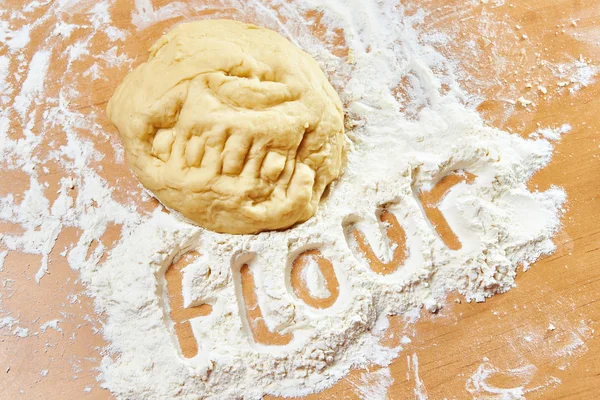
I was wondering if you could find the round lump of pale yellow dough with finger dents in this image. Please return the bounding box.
[107,20,344,234]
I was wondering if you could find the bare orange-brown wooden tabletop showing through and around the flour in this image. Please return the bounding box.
[0,0,600,399]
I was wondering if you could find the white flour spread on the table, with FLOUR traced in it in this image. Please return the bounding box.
[0,0,565,399]
